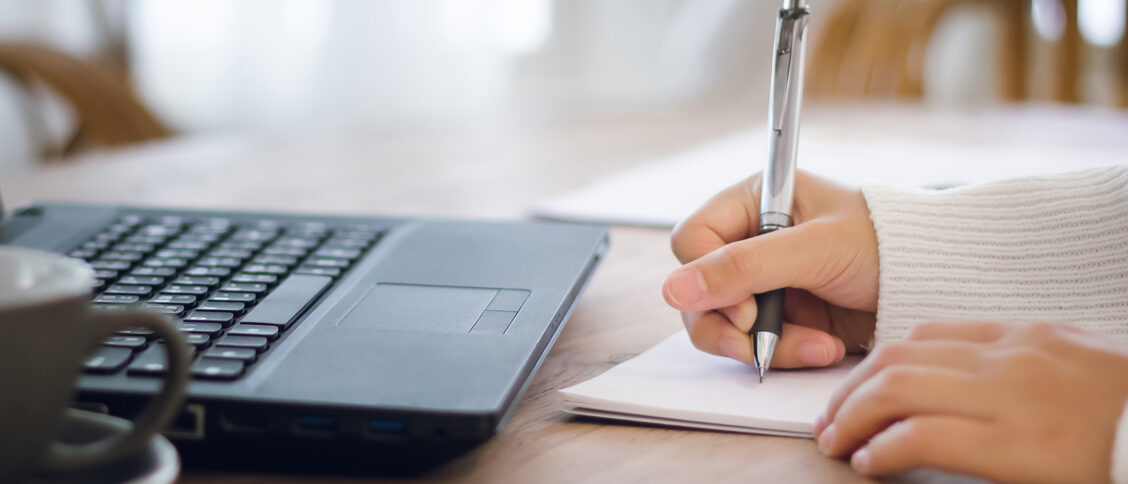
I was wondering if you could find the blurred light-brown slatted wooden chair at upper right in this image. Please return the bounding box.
[808,0,1128,106]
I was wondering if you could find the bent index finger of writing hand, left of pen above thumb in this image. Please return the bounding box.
[670,174,760,264]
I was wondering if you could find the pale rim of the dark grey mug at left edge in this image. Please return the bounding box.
[0,246,94,310]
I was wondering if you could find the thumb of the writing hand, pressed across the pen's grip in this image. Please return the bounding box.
[662,222,836,311]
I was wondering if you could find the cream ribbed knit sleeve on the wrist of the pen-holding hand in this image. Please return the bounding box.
[863,166,1128,343]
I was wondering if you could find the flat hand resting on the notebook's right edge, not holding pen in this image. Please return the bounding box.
[814,323,1128,483]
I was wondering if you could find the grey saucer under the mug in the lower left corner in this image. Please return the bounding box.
[28,408,180,484]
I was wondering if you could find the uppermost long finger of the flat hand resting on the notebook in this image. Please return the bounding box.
[814,341,984,437]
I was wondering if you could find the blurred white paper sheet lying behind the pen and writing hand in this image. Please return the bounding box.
[534,125,1125,227]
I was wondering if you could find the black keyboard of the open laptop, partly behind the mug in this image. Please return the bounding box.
[68,215,384,380]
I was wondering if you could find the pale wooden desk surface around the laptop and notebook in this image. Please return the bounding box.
[0,103,1055,483]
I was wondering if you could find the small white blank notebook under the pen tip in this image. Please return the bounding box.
[561,331,860,438]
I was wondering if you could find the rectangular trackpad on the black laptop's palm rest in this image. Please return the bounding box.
[337,284,507,333]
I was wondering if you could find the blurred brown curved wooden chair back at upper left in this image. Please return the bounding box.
[0,43,170,159]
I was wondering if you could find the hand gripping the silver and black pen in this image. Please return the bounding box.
[662,171,878,368]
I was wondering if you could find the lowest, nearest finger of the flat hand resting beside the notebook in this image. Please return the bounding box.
[851,415,1003,476]
